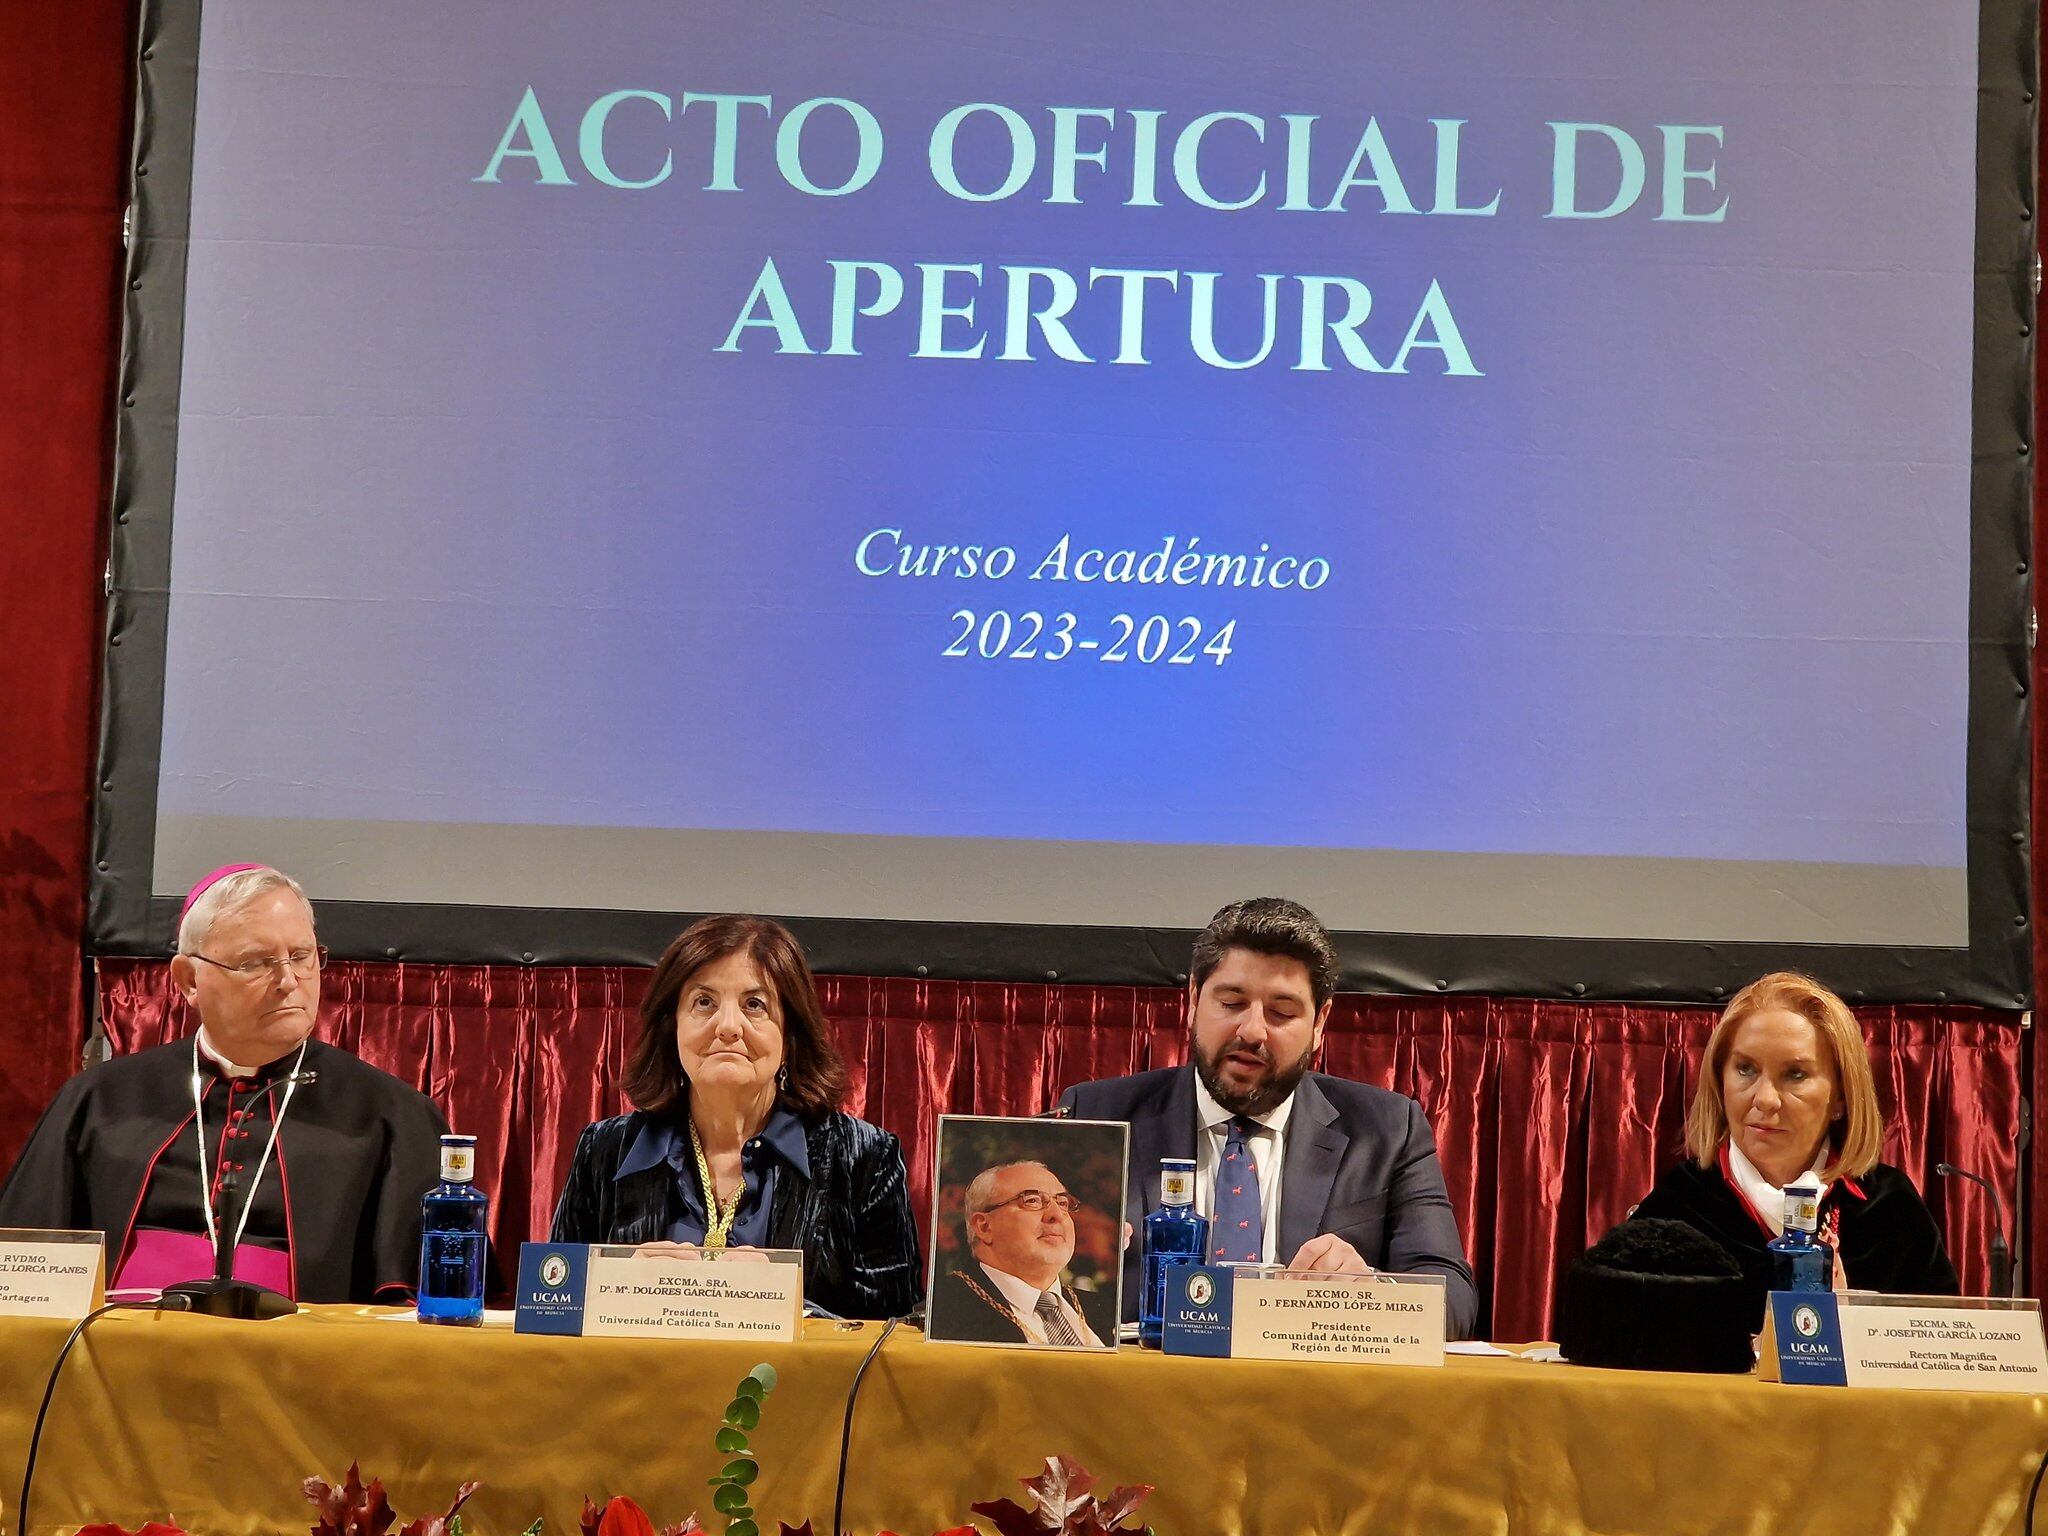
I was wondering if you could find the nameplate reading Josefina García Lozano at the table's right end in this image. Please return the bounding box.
[1757,1290,2048,1393]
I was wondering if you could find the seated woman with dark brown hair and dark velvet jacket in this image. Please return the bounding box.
[551,915,920,1317]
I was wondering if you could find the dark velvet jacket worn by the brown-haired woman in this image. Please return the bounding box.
[551,1110,922,1317]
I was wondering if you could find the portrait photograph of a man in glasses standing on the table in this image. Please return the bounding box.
[924,1114,1130,1350]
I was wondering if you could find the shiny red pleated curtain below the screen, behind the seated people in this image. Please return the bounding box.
[100,961,2023,1339]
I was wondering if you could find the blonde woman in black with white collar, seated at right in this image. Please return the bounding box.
[1632,971,1956,1327]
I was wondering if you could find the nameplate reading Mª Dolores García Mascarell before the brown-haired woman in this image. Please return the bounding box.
[512,1243,803,1339]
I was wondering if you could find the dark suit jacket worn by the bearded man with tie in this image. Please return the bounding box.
[1059,1065,1479,1339]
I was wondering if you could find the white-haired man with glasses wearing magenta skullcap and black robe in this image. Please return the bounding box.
[0,864,446,1303]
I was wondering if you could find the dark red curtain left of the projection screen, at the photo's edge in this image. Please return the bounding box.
[0,0,133,1167]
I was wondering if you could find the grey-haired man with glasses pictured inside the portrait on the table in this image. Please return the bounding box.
[926,1163,1116,1350]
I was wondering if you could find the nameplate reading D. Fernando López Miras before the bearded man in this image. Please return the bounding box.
[1161,1264,1444,1366]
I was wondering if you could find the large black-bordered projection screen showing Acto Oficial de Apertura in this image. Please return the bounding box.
[92,0,2034,1006]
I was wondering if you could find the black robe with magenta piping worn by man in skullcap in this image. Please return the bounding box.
[0,1040,446,1303]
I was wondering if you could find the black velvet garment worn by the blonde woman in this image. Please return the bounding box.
[1630,1159,1956,1331]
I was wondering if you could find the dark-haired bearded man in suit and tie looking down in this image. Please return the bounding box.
[1059,897,1479,1339]
